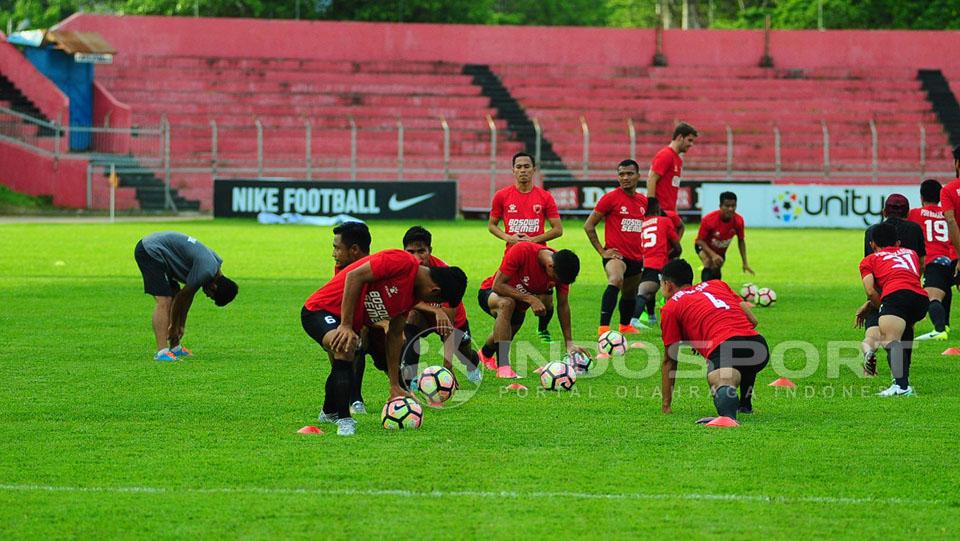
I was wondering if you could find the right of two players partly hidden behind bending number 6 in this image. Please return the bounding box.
[403,225,482,388]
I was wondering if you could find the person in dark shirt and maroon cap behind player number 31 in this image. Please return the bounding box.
[861,193,926,376]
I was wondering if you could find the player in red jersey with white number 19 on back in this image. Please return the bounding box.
[907,178,957,340]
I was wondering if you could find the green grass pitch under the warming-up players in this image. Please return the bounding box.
[0,220,960,539]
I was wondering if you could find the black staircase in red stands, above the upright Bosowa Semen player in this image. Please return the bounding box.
[463,64,573,180]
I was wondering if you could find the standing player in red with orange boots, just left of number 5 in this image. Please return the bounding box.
[583,160,647,336]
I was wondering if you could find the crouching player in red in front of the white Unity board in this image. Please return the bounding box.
[695,192,755,282]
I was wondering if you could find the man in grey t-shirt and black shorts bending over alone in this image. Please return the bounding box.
[133,231,238,361]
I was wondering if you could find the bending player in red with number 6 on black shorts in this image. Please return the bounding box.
[300,250,467,436]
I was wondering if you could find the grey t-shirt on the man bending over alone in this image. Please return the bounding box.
[141,231,223,289]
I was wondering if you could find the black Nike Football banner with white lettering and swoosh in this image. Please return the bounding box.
[213,179,457,220]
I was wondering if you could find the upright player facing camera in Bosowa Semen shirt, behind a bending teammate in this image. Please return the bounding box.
[487,152,563,342]
